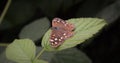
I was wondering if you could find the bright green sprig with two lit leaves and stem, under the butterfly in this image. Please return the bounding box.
[6,18,106,63]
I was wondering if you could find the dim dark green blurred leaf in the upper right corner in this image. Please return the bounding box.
[96,0,120,23]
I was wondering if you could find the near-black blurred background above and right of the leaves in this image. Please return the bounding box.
[0,0,120,63]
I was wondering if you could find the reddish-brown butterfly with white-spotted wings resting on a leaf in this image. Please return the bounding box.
[50,18,75,48]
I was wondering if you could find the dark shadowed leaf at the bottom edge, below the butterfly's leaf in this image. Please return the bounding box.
[50,48,92,63]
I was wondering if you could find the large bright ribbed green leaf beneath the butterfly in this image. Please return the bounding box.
[42,18,106,51]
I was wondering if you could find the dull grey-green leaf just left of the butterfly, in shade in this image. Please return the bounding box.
[19,17,50,41]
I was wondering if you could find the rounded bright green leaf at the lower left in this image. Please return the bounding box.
[6,39,36,63]
